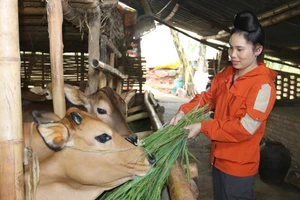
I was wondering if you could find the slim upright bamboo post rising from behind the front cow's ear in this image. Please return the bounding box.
[47,0,66,118]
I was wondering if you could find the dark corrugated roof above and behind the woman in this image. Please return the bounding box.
[142,0,300,65]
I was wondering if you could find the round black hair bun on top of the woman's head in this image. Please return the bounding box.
[233,10,260,32]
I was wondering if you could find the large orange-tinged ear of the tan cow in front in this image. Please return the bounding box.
[37,123,69,151]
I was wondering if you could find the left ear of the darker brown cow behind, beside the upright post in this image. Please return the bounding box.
[64,84,88,106]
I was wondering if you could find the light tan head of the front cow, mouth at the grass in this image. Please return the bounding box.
[37,108,151,190]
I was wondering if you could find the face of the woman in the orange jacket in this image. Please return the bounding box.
[228,33,262,76]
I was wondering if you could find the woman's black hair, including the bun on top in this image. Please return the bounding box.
[231,10,265,46]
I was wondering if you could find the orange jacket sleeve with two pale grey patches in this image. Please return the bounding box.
[200,83,276,142]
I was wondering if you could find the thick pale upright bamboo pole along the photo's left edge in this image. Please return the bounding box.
[0,0,24,200]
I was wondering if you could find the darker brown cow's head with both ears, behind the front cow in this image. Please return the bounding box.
[65,84,136,138]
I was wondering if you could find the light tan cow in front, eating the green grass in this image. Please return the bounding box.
[23,107,155,200]
